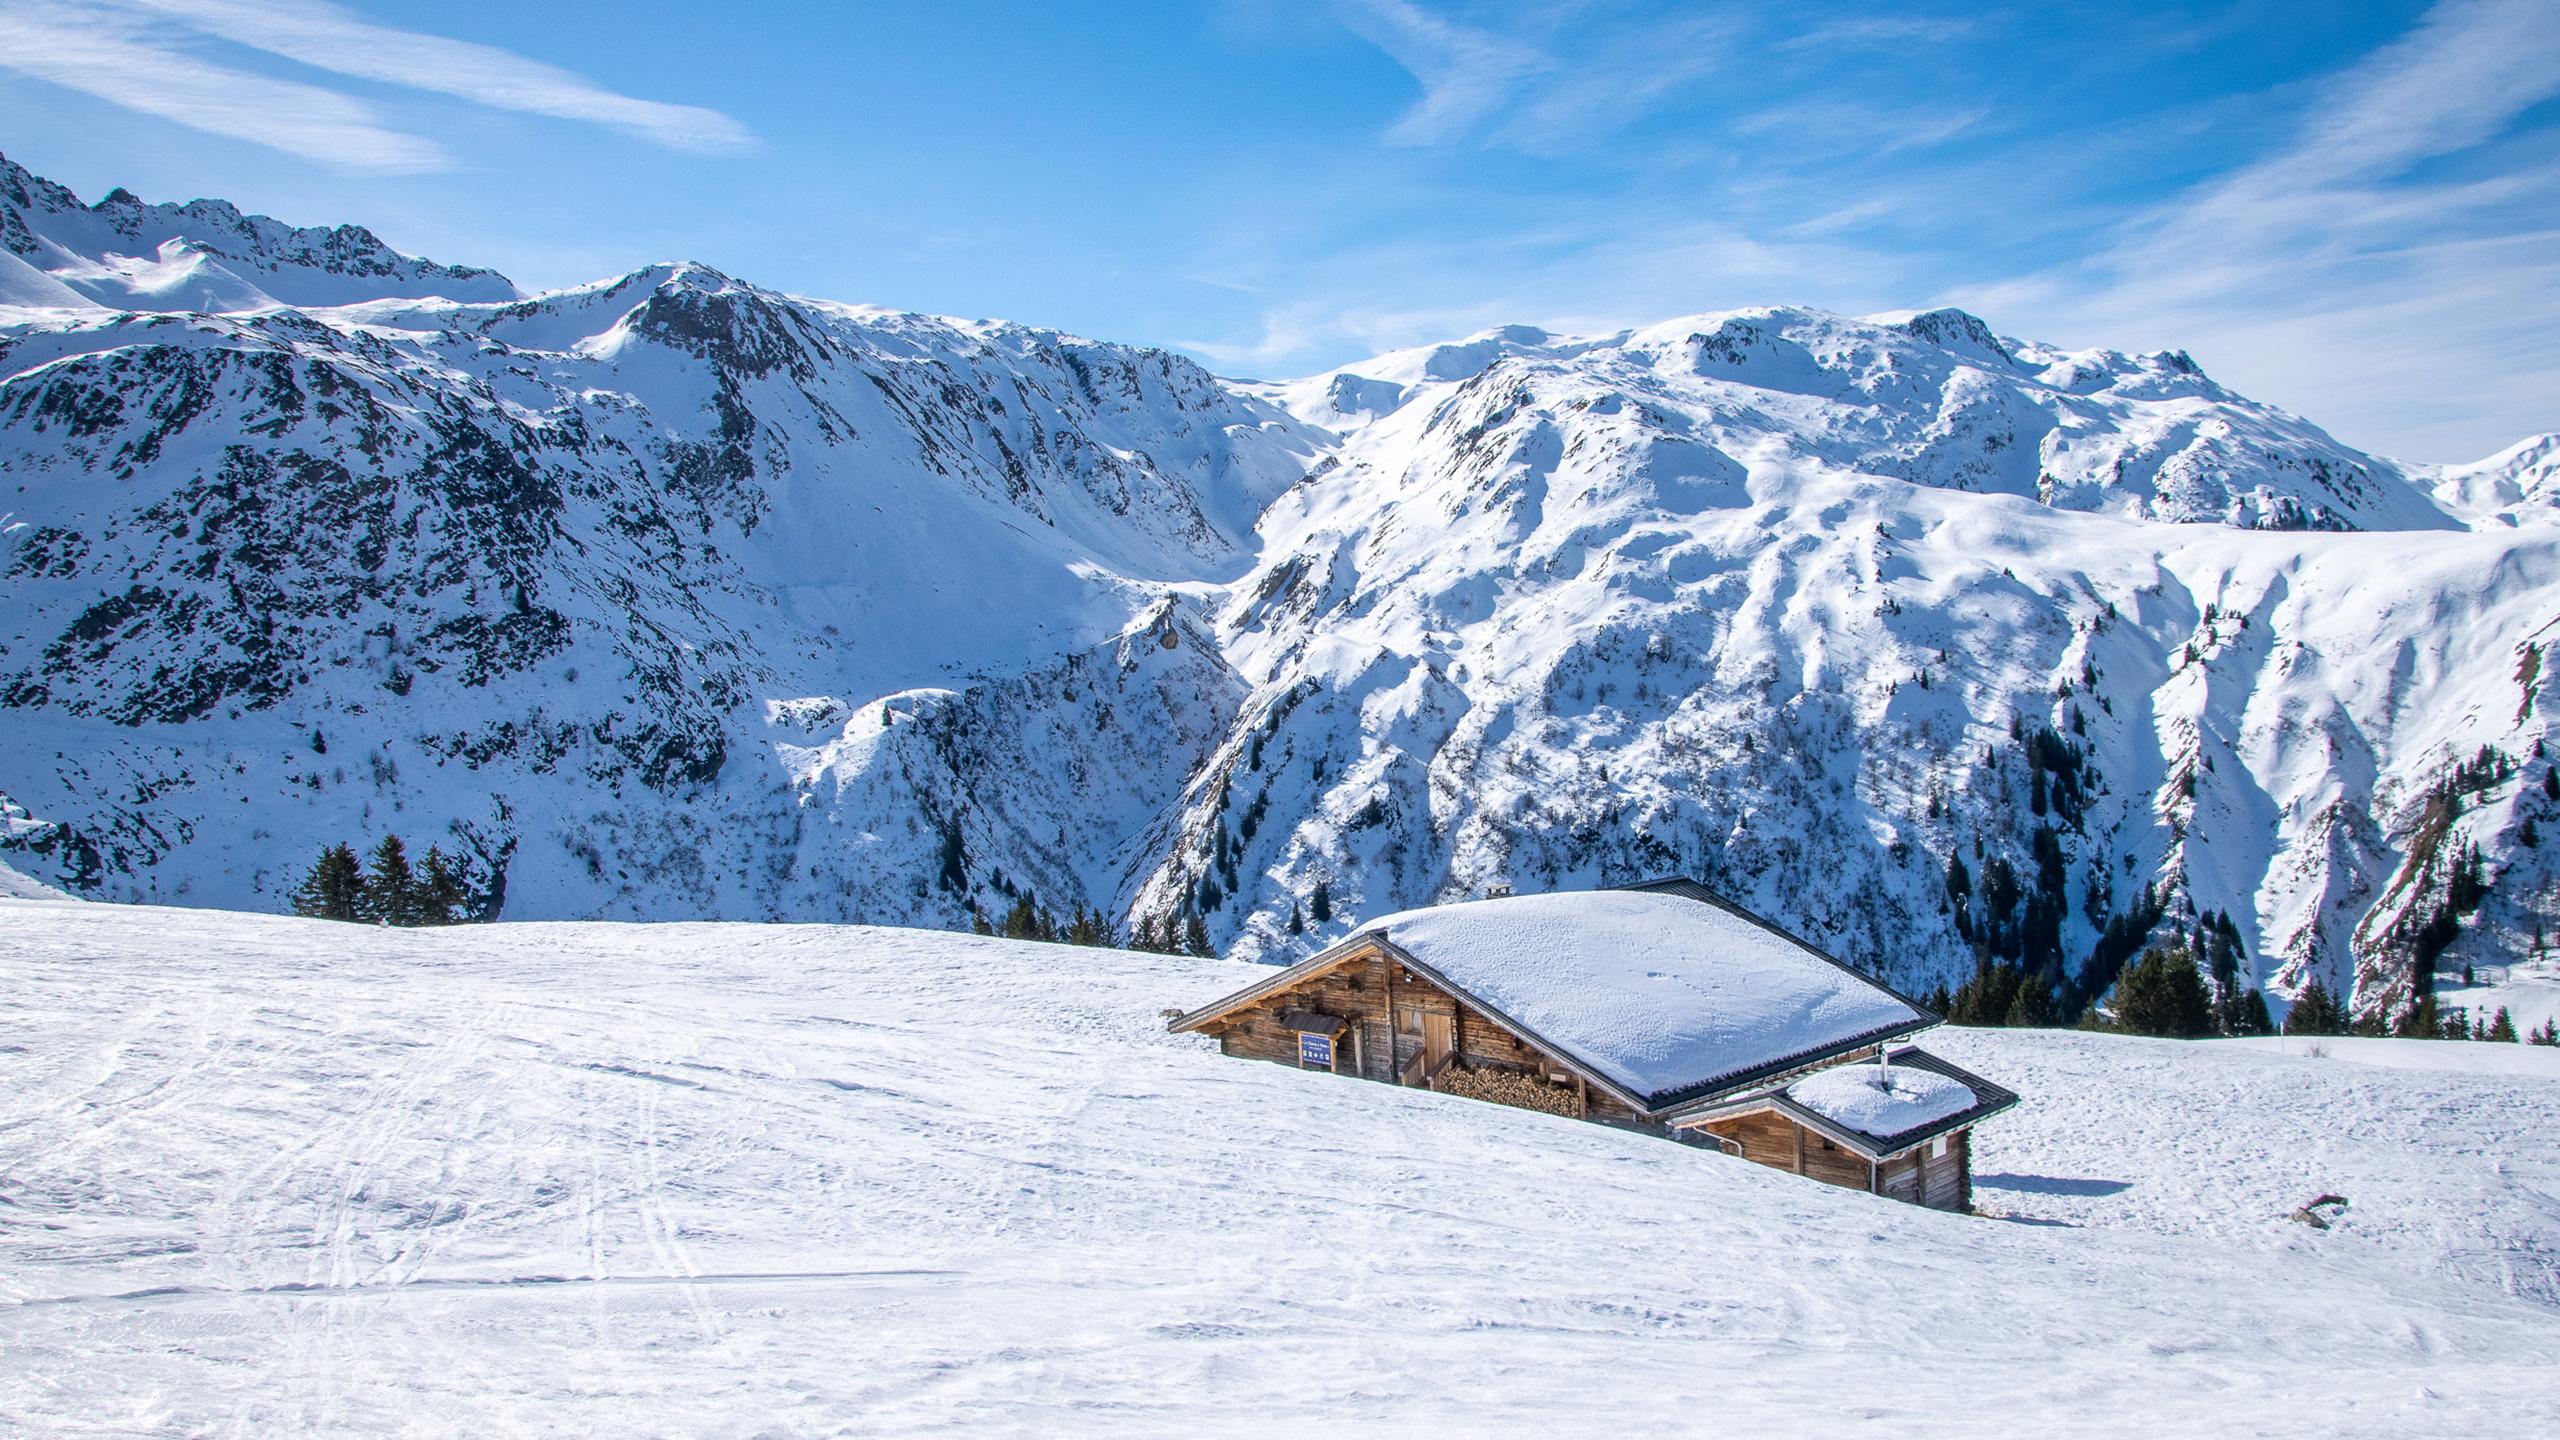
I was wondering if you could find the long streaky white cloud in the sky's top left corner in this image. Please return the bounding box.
[0,0,755,172]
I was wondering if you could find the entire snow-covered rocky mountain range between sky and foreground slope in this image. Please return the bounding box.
[0,161,2560,1010]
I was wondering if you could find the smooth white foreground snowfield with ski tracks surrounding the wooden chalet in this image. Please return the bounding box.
[0,902,2560,1437]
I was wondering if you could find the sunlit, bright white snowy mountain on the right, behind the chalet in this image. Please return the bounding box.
[1187,310,2560,1012]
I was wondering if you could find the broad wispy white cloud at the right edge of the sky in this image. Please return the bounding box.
[1953,0,2560,461]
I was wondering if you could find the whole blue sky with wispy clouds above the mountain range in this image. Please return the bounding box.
[0,0,2560,459]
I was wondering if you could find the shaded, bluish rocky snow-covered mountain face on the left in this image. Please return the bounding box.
[0,151,1318,925]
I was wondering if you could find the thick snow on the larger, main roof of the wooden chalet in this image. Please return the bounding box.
[1357,889,1933,1102]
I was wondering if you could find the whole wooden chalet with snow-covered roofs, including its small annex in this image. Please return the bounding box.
[1170,879,2017,1209]
